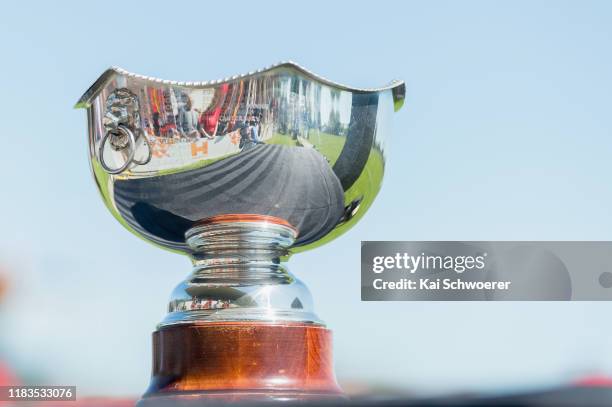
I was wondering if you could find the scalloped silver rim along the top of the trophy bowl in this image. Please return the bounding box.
[75,61,405,108]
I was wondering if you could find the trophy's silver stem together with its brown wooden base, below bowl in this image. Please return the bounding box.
[140,215,343,405]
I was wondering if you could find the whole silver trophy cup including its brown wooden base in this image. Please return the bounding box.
[77,62,405,405]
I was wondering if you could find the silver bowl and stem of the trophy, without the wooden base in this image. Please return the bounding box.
[77,62,405,324]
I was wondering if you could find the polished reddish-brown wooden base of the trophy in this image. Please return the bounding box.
[138,322,344,407]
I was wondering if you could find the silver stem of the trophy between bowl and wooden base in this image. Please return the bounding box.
[160,215,323,326]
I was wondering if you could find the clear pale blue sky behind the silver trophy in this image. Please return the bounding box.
[0,0,612,395]
